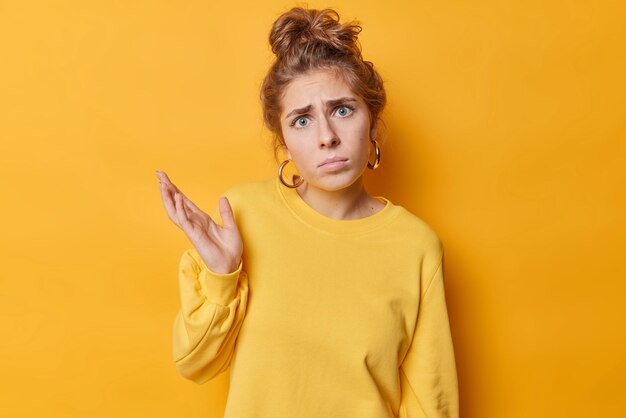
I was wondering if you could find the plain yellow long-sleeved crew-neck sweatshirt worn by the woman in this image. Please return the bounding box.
[173,178,459,418]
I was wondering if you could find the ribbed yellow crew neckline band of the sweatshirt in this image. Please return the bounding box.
[274,178,399,234]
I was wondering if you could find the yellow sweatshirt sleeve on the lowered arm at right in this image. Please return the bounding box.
[399,263,459,418]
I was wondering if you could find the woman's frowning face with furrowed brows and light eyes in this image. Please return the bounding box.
[280,70,374,191]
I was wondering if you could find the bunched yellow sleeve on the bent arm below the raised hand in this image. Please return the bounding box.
[173,248,248,384]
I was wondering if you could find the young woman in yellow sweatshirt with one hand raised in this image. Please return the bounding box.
[157,8,458,418]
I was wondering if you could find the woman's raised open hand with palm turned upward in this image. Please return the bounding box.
[157,171,243,274]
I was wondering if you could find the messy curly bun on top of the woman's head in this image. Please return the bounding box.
[269,7,361,60]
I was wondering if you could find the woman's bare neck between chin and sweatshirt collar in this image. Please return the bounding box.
[296,178,385,220]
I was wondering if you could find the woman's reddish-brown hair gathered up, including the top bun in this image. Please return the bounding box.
[261,7,386,160]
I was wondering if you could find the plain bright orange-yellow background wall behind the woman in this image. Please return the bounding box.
[0,0,626,418]
